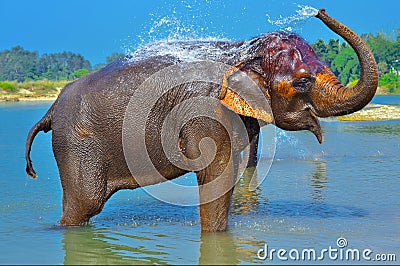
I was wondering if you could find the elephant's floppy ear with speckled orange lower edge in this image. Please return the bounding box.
[219,62,273,123]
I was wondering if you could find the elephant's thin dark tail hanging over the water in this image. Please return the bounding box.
[25,103,56,178]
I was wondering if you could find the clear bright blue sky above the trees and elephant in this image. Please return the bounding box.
[0,0,400,64]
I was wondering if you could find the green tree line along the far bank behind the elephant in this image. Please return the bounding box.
[0,29,400,93]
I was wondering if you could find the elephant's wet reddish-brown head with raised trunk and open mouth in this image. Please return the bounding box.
[220,9,378,142]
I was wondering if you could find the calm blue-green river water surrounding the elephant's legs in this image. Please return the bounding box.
[0,96,400,264]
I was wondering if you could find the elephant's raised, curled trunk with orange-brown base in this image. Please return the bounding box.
[312,9,378,117]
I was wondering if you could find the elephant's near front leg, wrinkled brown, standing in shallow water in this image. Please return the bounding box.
[180,116,239,232]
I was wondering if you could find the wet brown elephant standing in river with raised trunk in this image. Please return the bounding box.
[25,9,378,232]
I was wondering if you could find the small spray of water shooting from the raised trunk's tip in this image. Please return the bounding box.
[266,5,318,32]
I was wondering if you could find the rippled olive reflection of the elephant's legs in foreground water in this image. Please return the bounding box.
[62,226,261,265]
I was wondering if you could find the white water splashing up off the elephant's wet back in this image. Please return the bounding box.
[125,0,223,62]
